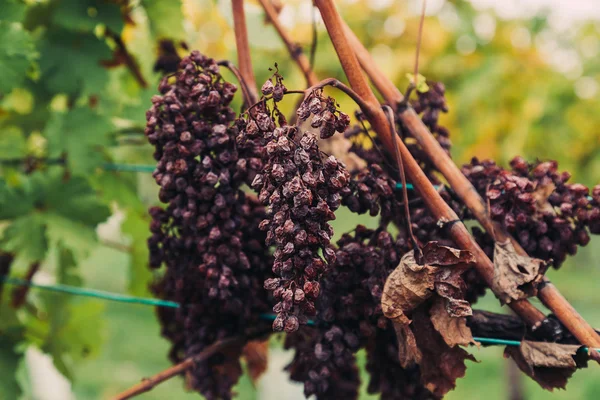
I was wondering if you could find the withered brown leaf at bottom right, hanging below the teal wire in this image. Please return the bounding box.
[504,340,581,391]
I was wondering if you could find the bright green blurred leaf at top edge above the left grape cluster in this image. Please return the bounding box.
[142,0,185,39]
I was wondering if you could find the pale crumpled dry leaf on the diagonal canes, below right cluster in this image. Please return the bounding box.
[492,240,546,304]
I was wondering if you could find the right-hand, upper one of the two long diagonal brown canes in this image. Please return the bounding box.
[344,18,600,347]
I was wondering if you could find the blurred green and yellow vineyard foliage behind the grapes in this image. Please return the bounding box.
[0,0,600,400]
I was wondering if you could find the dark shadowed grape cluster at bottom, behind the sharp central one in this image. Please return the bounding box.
[286,225,436,399]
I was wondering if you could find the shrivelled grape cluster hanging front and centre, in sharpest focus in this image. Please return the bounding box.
[246,120,350,332]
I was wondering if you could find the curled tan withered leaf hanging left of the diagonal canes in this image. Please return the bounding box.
[381,250,437,324]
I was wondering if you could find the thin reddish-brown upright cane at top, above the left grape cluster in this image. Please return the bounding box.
[231,0,258,105]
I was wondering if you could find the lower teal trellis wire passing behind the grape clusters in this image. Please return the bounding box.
[0,277,600,352]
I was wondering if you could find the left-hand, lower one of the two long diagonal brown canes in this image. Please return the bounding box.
[314,0,545,326]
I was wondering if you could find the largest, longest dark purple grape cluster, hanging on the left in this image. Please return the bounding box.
[145,52,272,399]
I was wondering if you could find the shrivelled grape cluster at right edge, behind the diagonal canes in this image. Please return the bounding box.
[463,157,600,268]
